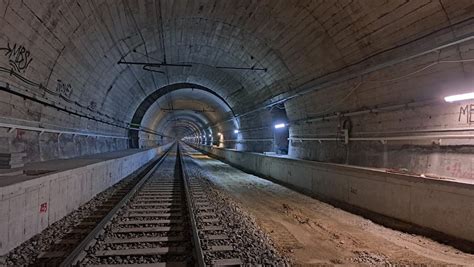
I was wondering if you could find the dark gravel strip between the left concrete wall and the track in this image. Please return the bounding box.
[0,170,144,266]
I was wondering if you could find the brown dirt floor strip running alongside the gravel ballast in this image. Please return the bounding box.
[183,147,474,265]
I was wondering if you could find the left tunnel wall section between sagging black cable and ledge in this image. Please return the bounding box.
[0,90,128,163]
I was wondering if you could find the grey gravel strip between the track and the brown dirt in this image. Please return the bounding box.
[185,157,290,266]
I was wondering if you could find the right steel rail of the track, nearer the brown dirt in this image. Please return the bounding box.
[177,143,206,267]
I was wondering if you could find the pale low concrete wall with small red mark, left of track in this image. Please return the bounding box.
[0,143,172,255]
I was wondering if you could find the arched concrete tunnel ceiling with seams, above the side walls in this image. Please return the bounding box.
[0,0,469,139]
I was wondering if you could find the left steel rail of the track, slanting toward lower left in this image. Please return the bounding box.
[59,145,175,267]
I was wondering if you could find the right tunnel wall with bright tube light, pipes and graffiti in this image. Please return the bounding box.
[285,28,474,179]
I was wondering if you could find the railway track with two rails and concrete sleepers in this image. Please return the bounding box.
[57,145,243,266]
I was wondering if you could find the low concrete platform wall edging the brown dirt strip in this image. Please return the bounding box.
[192,144,474,247]
